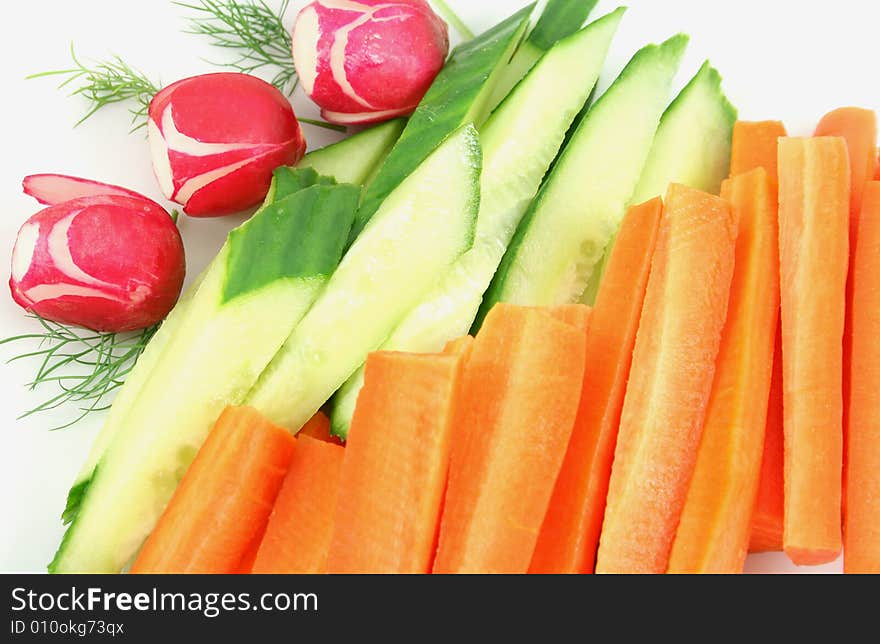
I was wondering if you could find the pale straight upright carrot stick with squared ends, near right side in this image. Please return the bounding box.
[779,137,850,565]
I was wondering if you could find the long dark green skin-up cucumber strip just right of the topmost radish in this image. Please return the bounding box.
[351,3,534,241]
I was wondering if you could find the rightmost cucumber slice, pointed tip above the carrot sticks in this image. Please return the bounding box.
[582,61,736,304]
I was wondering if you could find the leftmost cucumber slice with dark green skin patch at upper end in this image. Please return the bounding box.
[49,175,360,573]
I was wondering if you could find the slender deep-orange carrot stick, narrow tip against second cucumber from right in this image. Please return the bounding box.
[529,198,663,573]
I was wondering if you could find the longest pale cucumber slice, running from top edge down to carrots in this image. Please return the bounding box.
[330,9,624,438]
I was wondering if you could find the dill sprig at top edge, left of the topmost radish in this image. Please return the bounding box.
[174,0,298,95]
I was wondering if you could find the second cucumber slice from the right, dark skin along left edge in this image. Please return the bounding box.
[475,35,688,327]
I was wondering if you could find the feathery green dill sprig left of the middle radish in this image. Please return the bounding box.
[27,43,159,132]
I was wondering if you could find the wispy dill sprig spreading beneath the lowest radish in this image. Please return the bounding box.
[0,314,158,429]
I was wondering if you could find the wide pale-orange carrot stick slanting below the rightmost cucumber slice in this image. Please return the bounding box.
[596,184,736,573]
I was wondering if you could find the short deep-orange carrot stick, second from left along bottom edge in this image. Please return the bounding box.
[252,432,345,575]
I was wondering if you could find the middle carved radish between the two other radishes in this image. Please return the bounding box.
[147,73,306,217]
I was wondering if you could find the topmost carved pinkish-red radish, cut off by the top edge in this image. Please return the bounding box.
[293,0,449,124]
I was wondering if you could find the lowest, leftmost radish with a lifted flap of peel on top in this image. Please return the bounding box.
[9,175,186,332]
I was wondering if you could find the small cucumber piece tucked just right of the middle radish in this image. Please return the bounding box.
[297,119,406,186]
